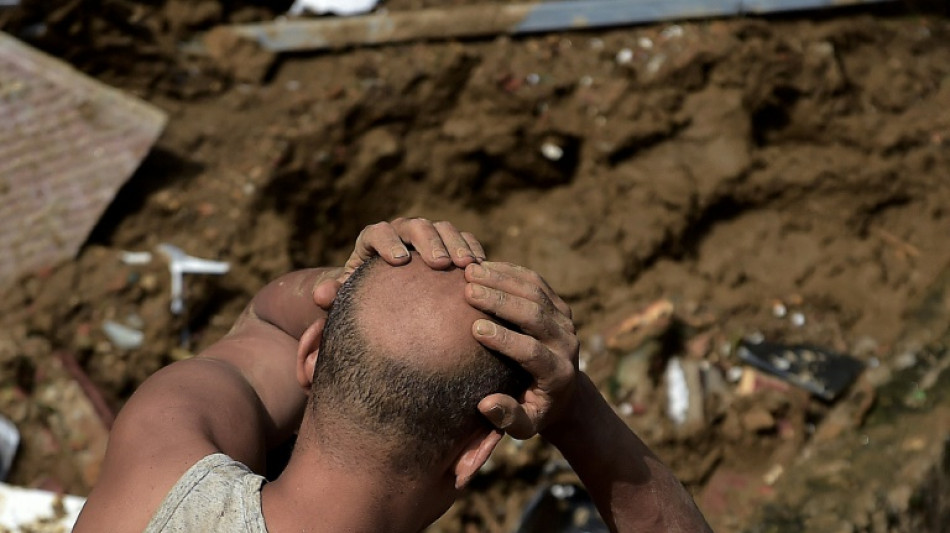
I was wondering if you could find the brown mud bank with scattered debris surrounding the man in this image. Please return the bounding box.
[0,0,950,531]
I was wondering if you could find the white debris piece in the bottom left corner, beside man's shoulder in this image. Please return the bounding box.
[0,483,86,531]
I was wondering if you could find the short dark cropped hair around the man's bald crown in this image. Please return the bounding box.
[310,258,530,473]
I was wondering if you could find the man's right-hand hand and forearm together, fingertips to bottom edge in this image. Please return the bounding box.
[465,261,712,533]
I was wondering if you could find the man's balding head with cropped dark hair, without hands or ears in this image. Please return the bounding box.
[309,254,529,475]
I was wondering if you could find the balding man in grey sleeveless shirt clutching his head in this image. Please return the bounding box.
[76,219,708,533]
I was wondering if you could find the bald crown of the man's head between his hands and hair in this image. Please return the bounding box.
[357,252,486,368]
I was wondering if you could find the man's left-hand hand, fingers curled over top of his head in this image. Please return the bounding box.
[313,218,485,309]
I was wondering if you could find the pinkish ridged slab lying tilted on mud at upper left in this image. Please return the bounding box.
[0,32,166,287]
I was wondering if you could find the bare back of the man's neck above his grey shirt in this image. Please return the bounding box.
[261,438,437,533]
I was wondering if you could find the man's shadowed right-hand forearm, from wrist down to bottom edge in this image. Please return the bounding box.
[542,374,711,533]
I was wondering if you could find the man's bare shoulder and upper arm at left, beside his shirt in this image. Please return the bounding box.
[75,358,263,533]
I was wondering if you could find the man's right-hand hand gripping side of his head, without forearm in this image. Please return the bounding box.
[465,261,579,439]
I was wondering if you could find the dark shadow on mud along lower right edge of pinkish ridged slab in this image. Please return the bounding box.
[83,147,204,247]
